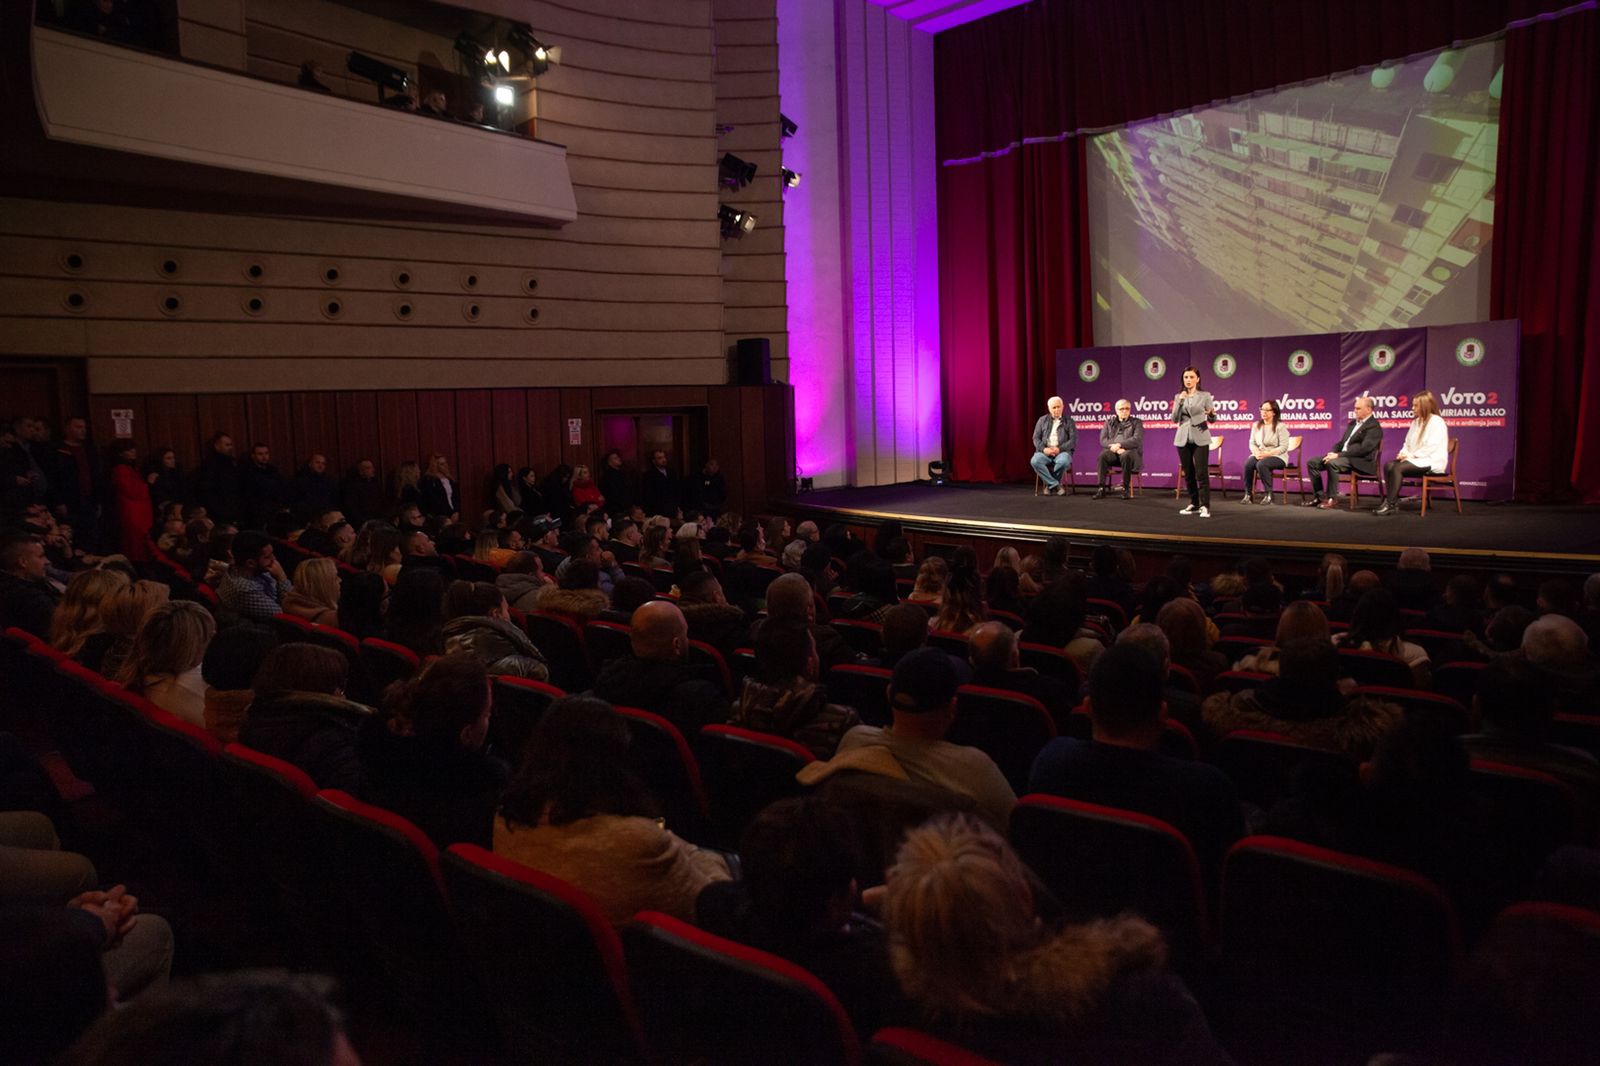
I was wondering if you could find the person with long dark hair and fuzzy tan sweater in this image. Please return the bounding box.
[494,696,728,925]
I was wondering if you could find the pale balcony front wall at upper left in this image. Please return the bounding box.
[21,26,578,226]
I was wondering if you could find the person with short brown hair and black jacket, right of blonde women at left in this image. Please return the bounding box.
[238,642,373,795]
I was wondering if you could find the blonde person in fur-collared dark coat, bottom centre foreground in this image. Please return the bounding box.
[883,815,1230,1064]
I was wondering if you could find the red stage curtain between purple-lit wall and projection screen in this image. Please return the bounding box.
[939,138,1090,482]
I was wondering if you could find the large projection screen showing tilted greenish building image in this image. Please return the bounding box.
[1090,43,1499,344]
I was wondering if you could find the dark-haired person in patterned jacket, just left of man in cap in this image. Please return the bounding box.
[728,619,861,759]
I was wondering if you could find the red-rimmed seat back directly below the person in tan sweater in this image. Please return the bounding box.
[442,844,648,1063]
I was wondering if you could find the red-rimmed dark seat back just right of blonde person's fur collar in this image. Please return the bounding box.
[1219,836,1461,1043]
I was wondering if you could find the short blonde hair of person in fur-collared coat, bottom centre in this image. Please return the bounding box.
[883,815,1042,1015]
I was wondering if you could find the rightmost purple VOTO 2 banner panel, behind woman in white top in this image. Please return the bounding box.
[1427,320,1522,499]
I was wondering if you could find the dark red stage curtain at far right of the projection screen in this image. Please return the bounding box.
[1491,10,1600,503]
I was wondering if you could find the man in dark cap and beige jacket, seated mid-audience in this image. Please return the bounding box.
[838,648,1016,832]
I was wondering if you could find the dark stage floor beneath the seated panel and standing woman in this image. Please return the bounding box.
[786,482,1600,573]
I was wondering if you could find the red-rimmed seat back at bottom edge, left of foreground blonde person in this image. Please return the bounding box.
[622,911,861,1066]
